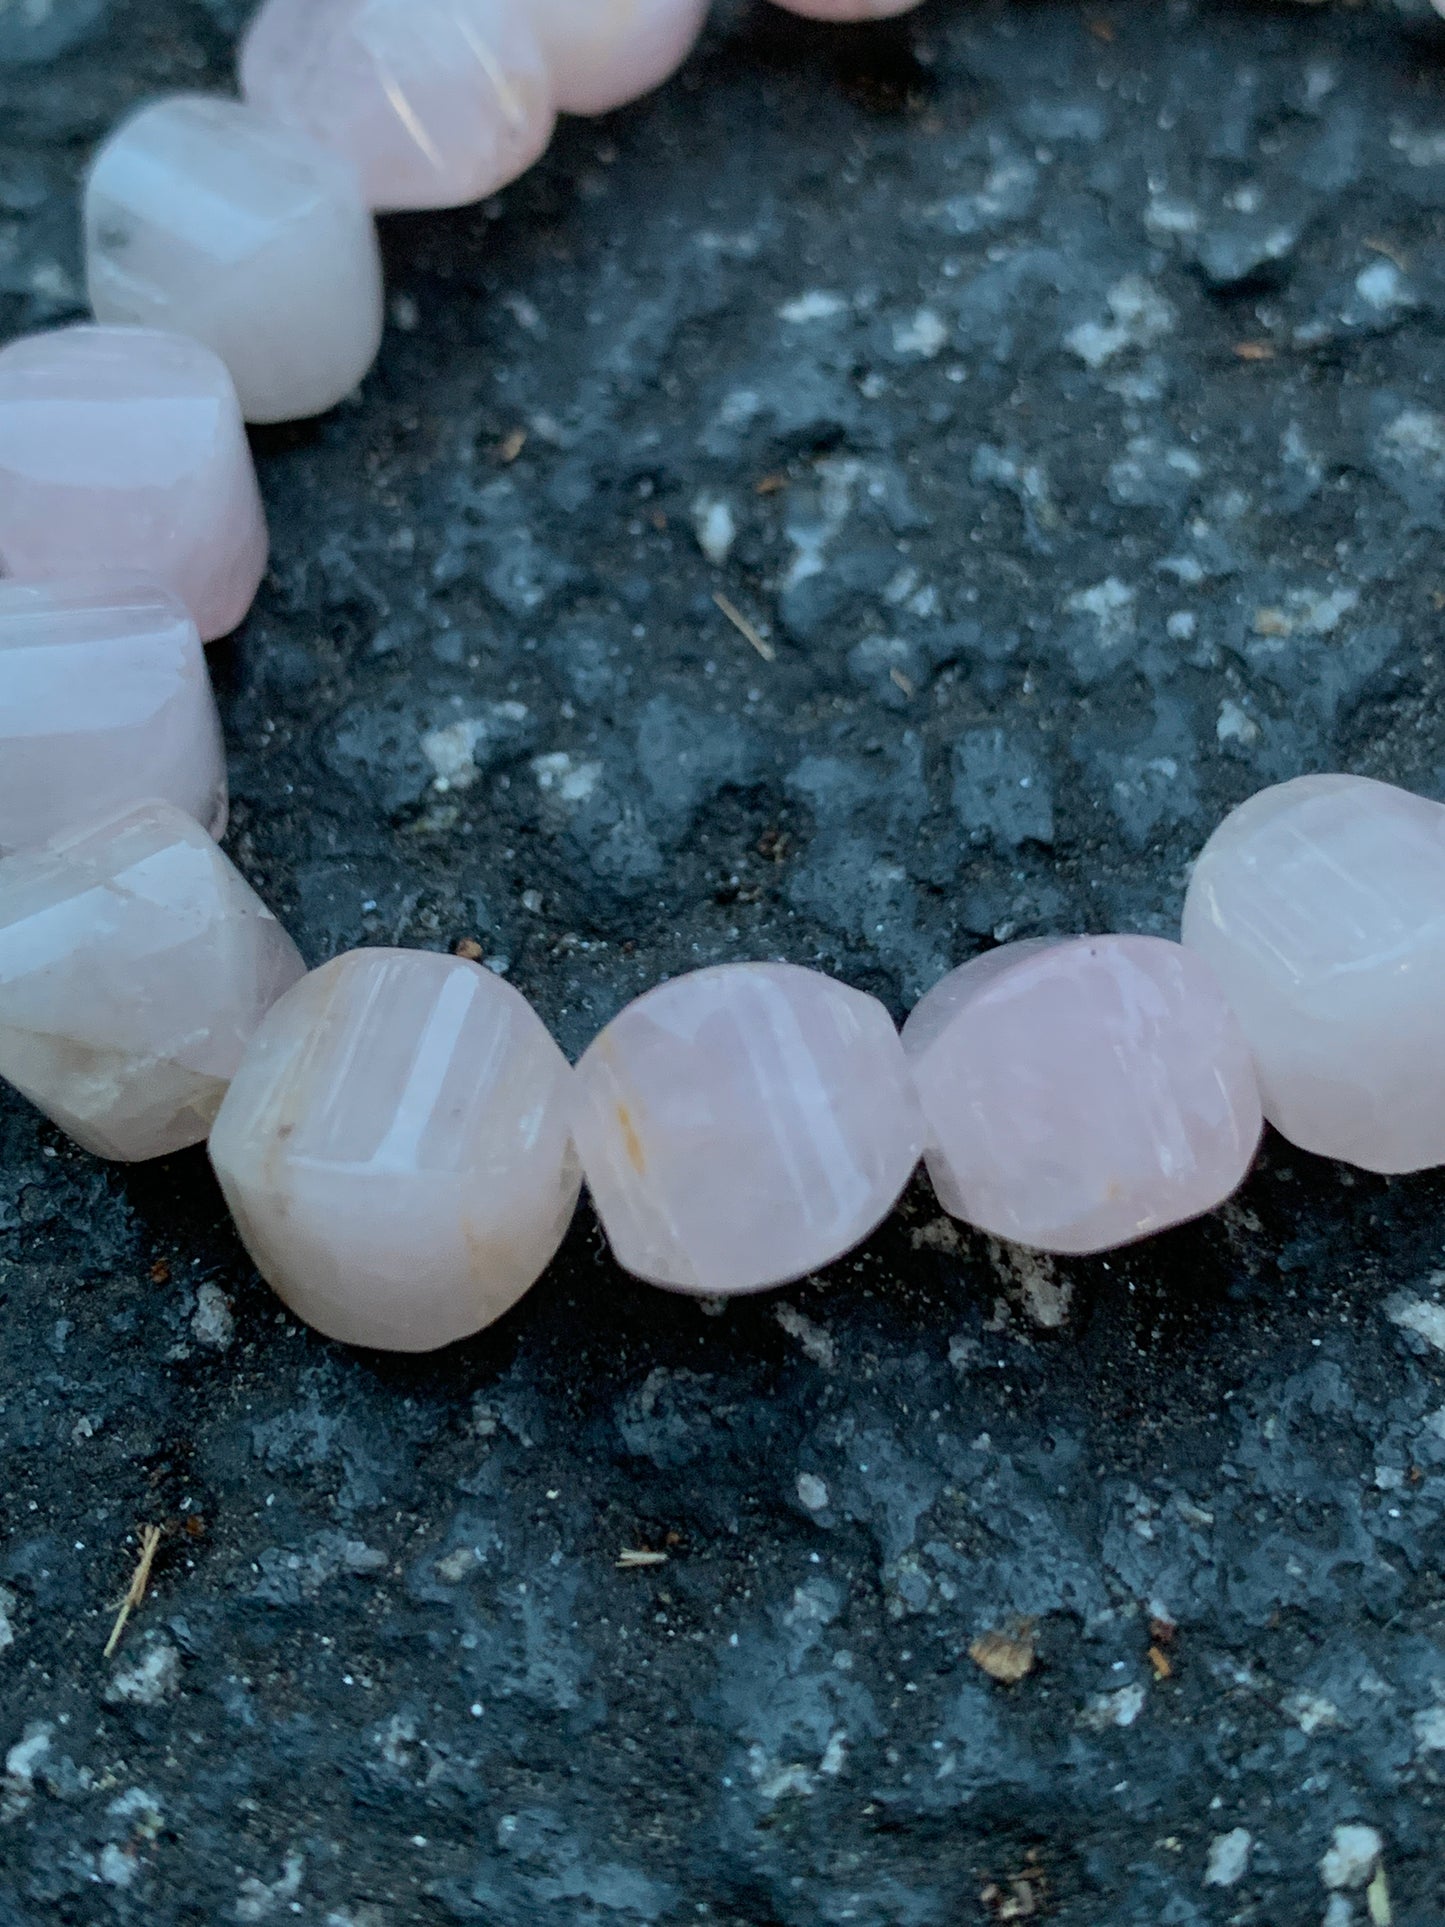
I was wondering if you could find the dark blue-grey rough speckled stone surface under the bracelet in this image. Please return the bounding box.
[0,0,1445,1927]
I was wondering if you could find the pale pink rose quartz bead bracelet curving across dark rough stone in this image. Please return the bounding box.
[0,0,1445,1351]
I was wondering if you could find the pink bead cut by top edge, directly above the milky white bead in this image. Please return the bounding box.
[241,0,555,208]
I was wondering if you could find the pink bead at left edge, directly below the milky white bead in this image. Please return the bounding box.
[0,328,266,642]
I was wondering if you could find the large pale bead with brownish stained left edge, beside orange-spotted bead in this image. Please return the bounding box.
[210,950,580,1351]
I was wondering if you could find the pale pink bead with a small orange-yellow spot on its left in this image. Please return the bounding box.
[572,964,923,1295]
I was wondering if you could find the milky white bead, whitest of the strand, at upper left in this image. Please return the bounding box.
[85,94,381,422]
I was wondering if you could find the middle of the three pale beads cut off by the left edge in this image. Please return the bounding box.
[0,580,225,856]
